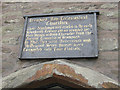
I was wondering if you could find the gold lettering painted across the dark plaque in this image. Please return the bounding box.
[23,15,93,52]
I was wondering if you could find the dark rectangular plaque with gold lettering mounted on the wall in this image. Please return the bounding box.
[20,11,99,59]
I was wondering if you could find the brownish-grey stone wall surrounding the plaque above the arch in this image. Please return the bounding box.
[2,2,118,81]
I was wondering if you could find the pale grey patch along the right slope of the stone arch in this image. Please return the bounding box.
[55,60,118,88]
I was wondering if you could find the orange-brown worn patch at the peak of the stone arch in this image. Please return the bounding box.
[26,64,88,86]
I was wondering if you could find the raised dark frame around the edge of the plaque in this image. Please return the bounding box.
[18,10,99,60]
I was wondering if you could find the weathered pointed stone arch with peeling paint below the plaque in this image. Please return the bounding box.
[1,60,119,89]
